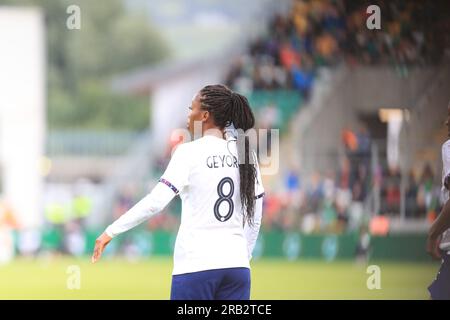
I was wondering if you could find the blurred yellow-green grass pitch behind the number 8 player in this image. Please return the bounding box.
[0,257,439,299]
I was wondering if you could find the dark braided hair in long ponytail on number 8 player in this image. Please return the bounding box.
[200,84,256,225]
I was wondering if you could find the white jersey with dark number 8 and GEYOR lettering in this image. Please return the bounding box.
[160,135,264,274]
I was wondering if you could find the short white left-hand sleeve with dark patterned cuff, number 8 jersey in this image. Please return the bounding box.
[159,144,192,194]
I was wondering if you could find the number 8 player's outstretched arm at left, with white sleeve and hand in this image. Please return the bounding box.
[92,145,189,263]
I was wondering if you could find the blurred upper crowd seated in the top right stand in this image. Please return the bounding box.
[226,0,450,99]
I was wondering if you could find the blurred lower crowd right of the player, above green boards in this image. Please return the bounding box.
[263,128,441,234]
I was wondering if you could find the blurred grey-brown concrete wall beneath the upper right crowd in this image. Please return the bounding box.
[283,65,450,181]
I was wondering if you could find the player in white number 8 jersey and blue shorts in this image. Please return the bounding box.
[92,85,264,300]
